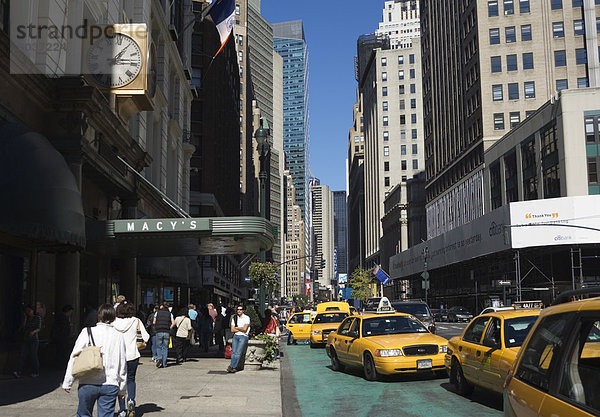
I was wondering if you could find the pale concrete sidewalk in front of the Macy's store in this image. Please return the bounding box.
[0,346,282,417]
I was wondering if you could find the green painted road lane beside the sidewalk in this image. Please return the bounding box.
[285,345,502,417]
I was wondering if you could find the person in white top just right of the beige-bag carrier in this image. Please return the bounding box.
[113,303,150,417]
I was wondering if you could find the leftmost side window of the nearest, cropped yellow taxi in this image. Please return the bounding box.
[515,313,572,392]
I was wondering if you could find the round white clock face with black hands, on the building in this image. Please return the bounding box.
[87,33,142,88]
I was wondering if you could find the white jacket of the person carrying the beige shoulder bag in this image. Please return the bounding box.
[62,323,127,395]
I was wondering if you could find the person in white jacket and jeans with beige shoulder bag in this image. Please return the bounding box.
[62,304,127,417]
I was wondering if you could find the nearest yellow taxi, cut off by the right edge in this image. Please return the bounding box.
[504,288,600,417]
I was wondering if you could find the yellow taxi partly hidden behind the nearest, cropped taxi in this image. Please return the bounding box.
[445,308,541,395]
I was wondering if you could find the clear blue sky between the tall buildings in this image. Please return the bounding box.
[261,0,383,191]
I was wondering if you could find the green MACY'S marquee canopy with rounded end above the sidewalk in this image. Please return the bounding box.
[88,217,275,257]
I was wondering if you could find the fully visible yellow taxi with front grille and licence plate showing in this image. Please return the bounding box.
[326,297,448,381]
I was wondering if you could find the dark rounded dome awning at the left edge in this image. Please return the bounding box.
[0,123,86,249]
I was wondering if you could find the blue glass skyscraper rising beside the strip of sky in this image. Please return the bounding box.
[272,20,309,223]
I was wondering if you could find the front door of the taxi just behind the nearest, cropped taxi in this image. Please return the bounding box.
[475,317,506,393]
